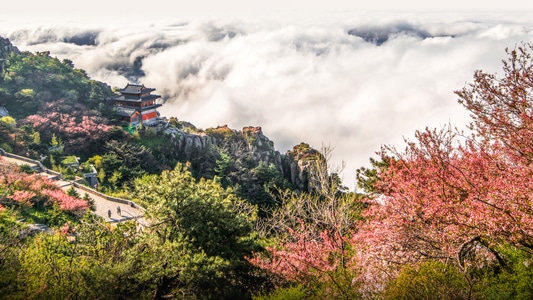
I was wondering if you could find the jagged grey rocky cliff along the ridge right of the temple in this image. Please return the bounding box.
[164,122,321,191]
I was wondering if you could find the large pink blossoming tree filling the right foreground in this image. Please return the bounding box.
[354,45,533,289]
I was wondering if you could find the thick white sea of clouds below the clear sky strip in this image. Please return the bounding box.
[0,14,533,187]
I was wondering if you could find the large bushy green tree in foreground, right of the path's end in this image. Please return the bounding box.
[135,164,261,299]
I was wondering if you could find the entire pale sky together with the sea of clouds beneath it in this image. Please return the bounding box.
[0,0,533,188]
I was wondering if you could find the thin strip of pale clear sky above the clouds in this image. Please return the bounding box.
[0,0,533,22]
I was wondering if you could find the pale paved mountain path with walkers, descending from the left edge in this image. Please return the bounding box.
[0,149,148,227]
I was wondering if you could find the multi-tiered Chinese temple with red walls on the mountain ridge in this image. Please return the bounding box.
[110,83,161,125]
